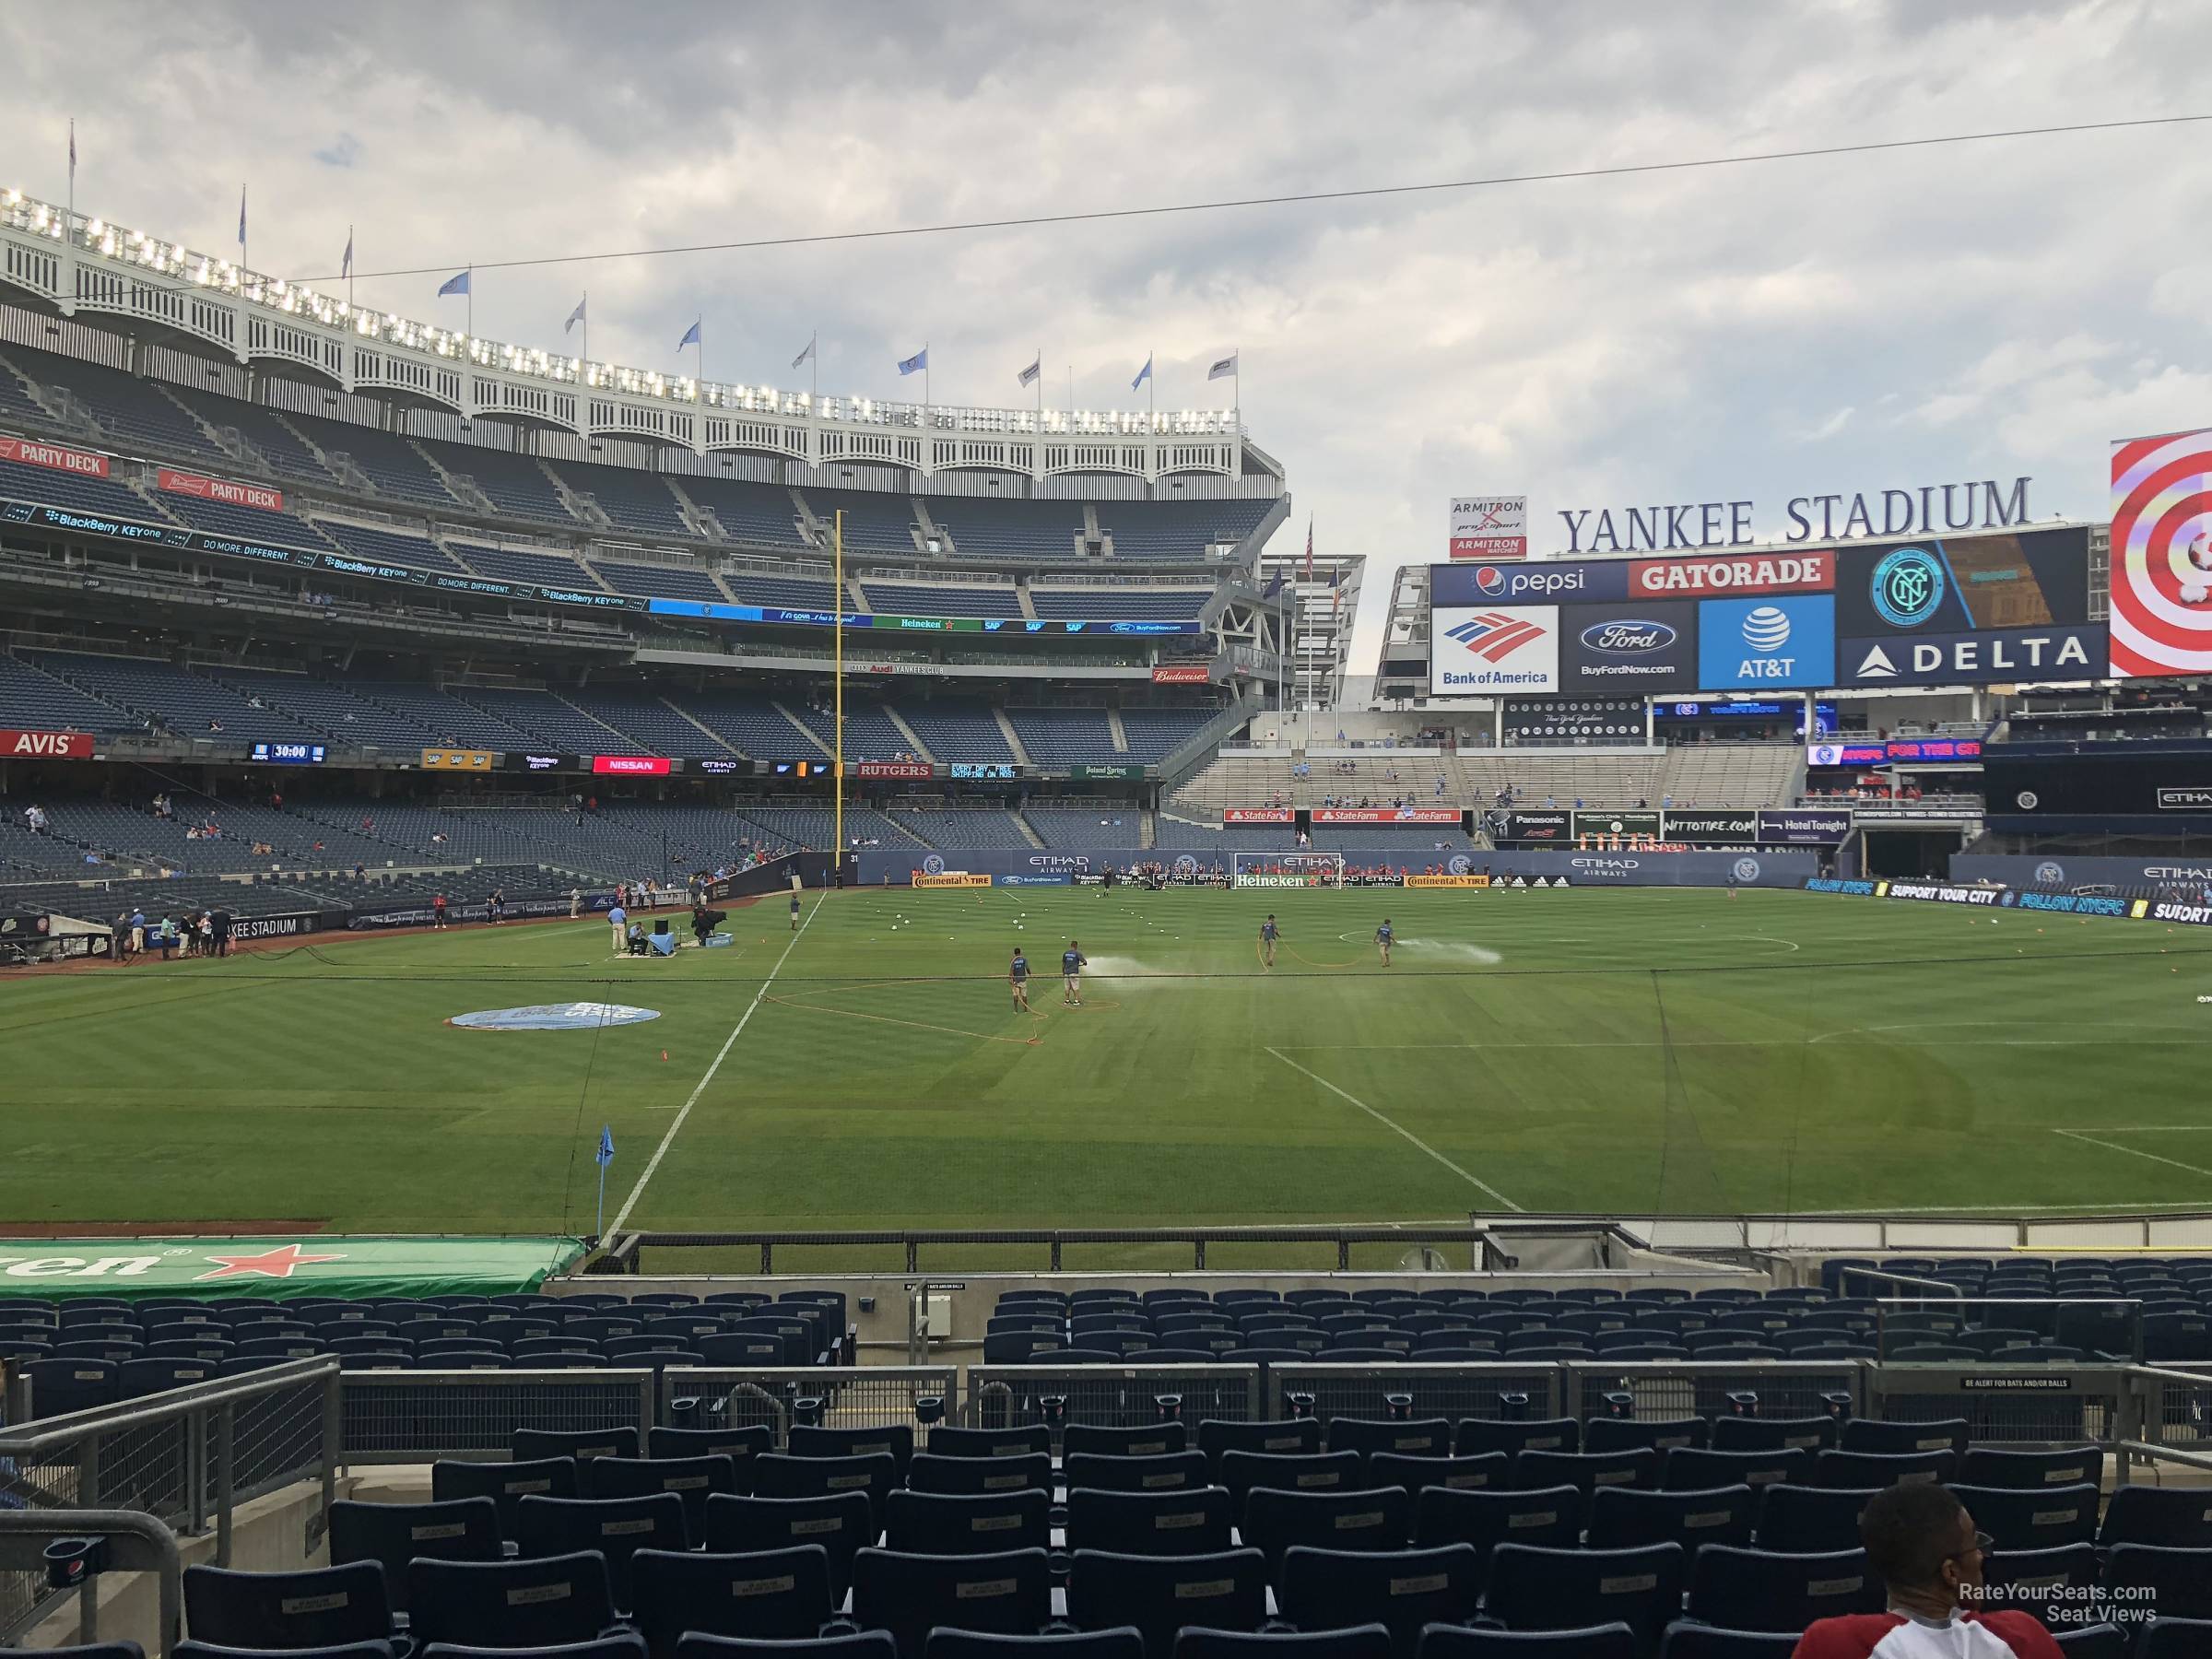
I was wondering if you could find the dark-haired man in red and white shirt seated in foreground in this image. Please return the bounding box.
[1794,1487,2066,1659]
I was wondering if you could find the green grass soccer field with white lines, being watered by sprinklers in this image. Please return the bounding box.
[13,887,2212,1265]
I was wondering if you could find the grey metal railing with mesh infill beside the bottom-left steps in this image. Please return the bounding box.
[0,1359,341,1639]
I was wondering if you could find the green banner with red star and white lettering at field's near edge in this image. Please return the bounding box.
[0,1234,584,1300]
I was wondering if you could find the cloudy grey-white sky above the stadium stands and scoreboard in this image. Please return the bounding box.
[0,0,2212,668]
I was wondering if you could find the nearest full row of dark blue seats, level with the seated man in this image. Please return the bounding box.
[160,1544,2212,1659]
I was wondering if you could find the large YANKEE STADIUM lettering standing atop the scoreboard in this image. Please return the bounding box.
[1559,477,2033,555]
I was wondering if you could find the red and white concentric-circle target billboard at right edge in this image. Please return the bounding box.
[2112,429,2212,679]
